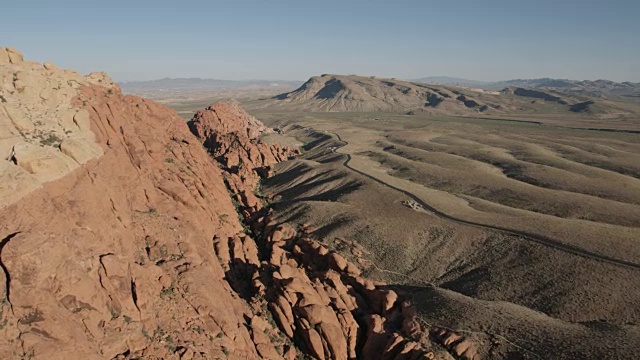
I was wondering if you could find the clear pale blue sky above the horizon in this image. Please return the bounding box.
[0,0,640,81]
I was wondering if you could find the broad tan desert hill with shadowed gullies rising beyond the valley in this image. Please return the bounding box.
[262,75,638,116]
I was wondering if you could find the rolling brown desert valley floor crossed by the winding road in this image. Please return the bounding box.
[240,109,640,359]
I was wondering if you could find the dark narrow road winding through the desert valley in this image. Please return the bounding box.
[327,132,640,270]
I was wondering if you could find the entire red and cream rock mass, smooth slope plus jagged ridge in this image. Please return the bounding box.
[0,48,478,359]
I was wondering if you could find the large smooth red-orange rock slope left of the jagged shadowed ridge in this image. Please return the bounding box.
[0,50,273,359]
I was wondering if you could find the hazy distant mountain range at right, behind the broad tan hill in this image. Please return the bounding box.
[414,76,640,102]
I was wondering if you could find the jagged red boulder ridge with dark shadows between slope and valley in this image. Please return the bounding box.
[189,102,476,360]
